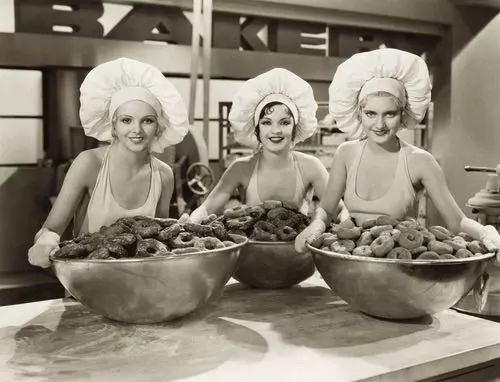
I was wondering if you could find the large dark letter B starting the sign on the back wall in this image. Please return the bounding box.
[15,0,104,37]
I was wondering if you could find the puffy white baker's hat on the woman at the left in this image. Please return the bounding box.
[80,57,189,153]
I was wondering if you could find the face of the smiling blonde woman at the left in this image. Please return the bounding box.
[114,101,158,152]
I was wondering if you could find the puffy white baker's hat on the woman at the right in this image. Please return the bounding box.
[329,48,432,138]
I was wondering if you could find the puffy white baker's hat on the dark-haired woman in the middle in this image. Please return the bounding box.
[229,68,318,147]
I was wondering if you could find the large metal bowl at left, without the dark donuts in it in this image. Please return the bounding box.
[52,235,248,323]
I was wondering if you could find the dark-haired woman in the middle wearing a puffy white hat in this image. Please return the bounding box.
[191,68,347,222]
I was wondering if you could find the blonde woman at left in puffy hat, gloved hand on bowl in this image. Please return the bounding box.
[28,58,189,267]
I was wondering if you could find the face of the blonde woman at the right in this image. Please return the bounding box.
[361,95,402,144]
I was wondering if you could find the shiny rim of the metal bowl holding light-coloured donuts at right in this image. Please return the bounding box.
[306,243,496,265]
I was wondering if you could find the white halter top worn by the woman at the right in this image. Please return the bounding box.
[344,139,416,225]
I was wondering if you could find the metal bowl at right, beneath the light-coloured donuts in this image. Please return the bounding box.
[307,244,495,319]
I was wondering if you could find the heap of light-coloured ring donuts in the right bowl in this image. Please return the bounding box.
[311,216,488,260]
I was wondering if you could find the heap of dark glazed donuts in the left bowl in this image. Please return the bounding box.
[51,215,237,260]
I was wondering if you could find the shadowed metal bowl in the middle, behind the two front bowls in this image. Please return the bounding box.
[233,240,315,289]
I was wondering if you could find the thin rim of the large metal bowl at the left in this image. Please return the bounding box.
[50,234,248,264]
